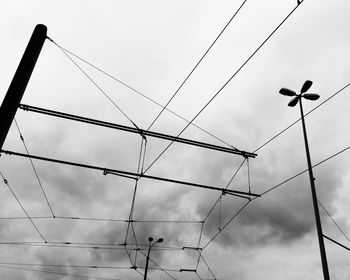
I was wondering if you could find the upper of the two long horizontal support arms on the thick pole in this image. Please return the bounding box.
[19,104,256,158]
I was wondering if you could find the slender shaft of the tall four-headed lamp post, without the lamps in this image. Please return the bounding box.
[299,95,330,280]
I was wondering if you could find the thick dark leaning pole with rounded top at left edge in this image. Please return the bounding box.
[0,24,47,149]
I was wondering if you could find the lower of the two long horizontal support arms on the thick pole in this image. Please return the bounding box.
[0,150,260,200]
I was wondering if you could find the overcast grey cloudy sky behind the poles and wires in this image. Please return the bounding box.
[0,0,350,280]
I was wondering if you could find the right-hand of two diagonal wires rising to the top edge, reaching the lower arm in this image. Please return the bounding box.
[145,1,304,172]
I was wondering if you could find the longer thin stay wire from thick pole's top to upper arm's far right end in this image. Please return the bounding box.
[47,42,235,151]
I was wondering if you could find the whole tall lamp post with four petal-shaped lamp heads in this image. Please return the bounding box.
[279,81,330,280]
